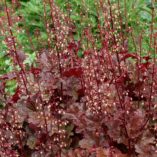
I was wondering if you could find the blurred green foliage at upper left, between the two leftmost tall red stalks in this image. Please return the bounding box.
[15,0,47,53]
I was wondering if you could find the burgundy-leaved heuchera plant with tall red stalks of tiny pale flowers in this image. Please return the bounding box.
[0,0,157,157]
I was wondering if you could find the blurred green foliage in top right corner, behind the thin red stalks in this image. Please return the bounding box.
[120,0,157,52]
